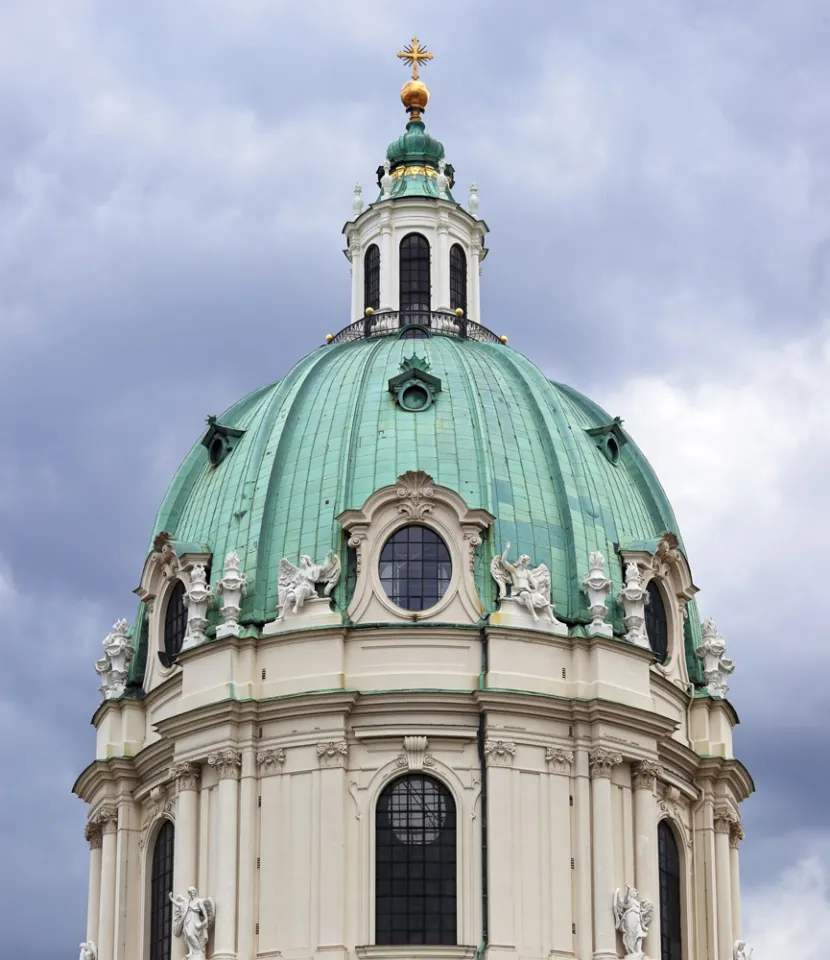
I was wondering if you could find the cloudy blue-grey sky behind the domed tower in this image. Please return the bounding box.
[0,0,830,960]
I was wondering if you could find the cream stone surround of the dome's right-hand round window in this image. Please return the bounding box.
[619,532,698,690]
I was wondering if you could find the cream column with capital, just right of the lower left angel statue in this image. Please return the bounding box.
[208,750,242,960]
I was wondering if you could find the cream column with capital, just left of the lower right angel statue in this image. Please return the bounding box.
[590,750,622,960]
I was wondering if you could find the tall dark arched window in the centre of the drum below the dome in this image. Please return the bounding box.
[375,774,457,946]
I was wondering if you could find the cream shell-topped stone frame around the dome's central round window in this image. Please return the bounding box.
[337,470,495,623]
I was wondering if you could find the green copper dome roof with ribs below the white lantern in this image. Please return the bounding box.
[133,335,700,677]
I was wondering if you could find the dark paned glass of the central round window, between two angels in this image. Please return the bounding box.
[380,526,452,610]
